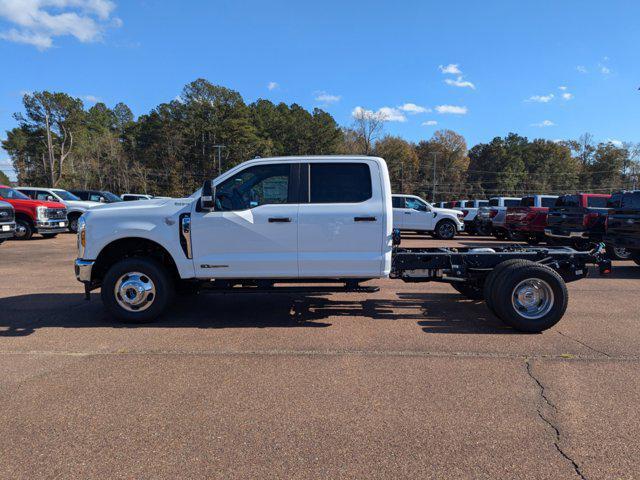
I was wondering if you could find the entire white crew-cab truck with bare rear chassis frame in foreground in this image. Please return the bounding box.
[75,156,610,332]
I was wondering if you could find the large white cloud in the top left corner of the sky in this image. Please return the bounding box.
[0,0,122,50]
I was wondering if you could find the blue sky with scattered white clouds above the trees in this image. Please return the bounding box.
[0,0,640,179]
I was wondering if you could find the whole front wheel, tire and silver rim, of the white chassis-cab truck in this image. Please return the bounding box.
[100,258,174,323]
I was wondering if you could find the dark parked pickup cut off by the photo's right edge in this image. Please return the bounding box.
[604,190,640,265]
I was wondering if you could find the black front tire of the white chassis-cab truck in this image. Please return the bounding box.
[100,258,175,323]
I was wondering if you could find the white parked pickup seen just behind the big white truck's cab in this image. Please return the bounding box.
[392,195,464,240]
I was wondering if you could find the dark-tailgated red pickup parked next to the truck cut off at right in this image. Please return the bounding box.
[544,193,611,250]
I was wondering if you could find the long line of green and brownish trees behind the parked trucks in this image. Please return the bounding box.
[2,79,640,200]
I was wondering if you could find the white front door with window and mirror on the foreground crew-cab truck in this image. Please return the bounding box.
[191,163,299,278]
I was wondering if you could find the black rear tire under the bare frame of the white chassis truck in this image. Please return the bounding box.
[494,262,569,333]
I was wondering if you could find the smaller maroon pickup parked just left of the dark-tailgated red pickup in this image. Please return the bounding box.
[506,195,558,244]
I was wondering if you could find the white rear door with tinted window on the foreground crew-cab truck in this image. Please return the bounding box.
[298,159,386,278]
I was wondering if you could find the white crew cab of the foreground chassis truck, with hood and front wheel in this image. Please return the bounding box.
[76,156,393,321]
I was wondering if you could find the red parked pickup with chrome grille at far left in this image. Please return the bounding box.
[0,185,68,240]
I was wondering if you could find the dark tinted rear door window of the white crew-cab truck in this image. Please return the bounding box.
[309,163,372,203]
